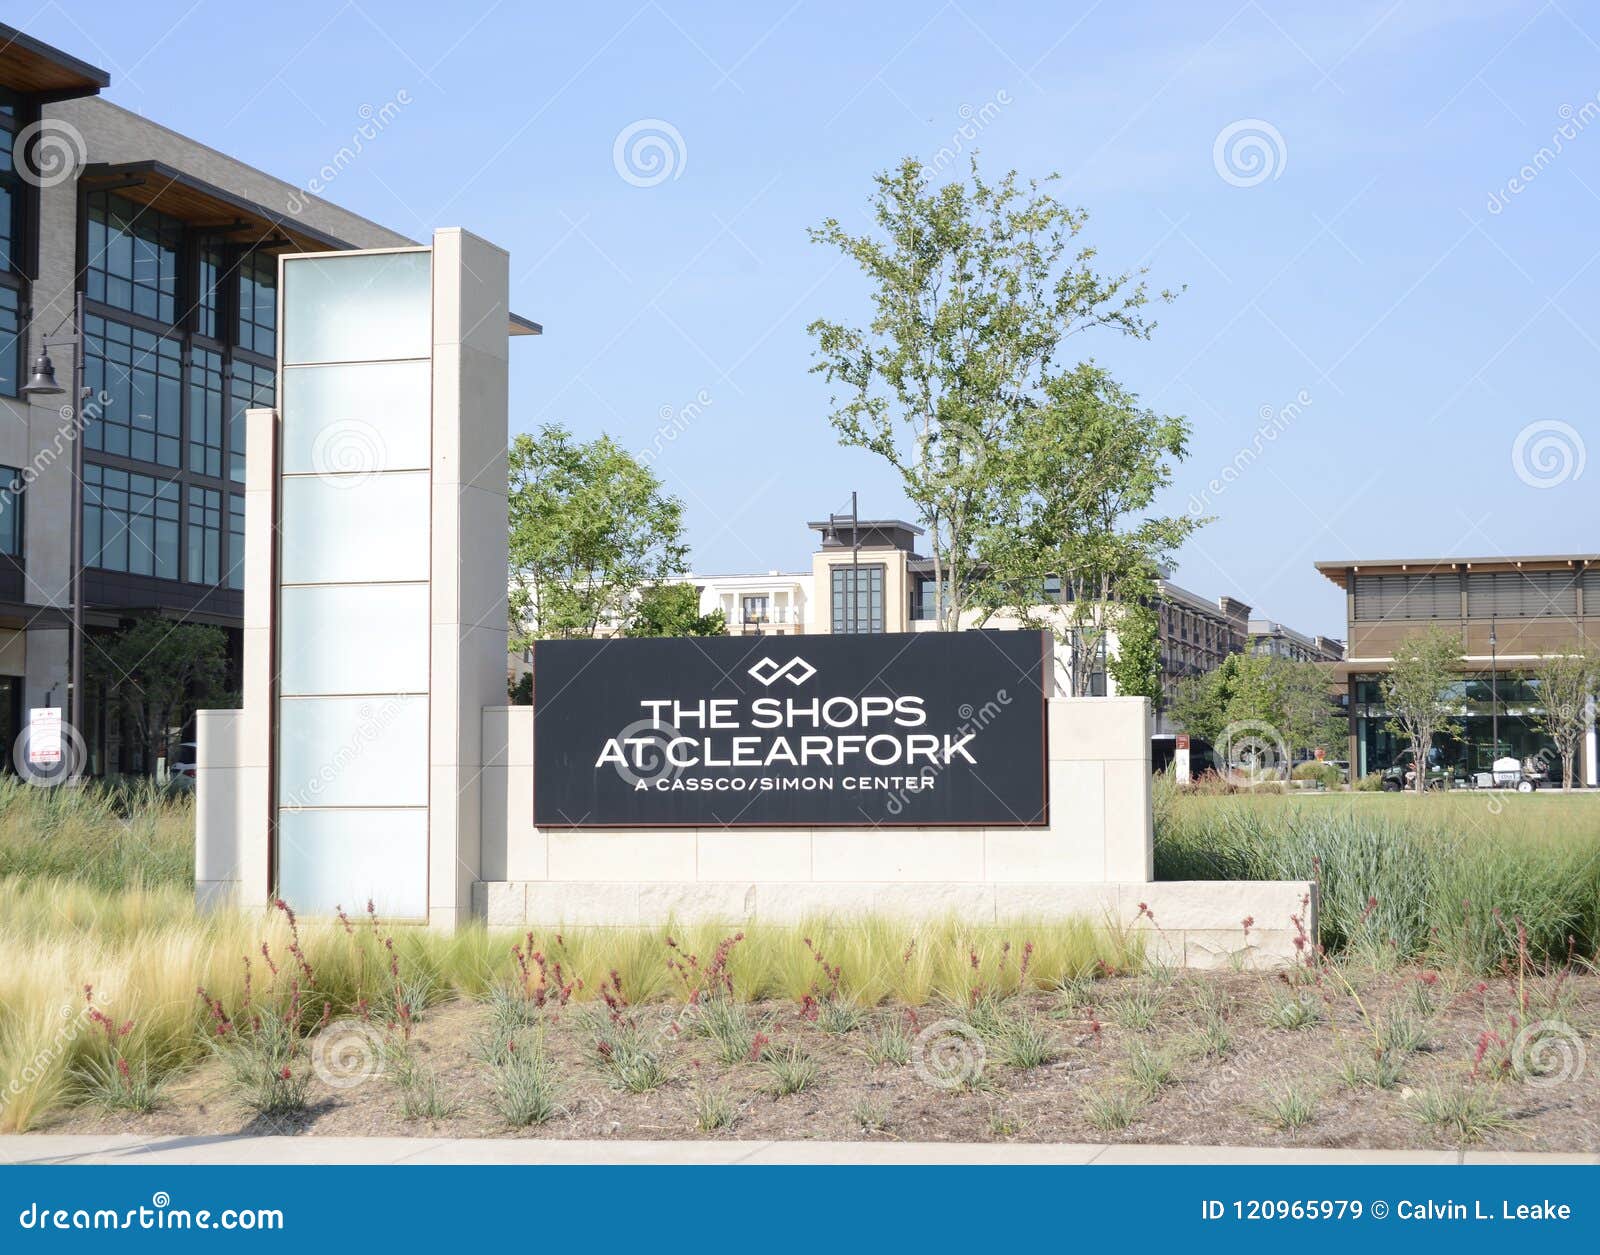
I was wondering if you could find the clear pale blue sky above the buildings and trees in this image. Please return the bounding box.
[34,0,1600,634]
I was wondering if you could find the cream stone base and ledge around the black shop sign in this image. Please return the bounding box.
[472,698,1315,967]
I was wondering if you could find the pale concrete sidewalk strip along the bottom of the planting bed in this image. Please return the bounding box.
[0,1133,1600,1165]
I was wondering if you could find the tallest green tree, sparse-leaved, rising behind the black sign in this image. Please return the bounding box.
[808,157,1171,631]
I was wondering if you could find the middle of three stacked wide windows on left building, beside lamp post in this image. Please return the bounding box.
[83,315,182,466]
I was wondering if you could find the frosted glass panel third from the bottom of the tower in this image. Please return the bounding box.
[278,584,429,696]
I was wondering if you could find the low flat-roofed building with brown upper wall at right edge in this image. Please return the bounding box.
[1317,554,1600,786]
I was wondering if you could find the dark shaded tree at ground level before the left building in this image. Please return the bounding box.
[83,615,237,768]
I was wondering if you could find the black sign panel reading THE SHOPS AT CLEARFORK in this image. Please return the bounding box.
[533,632,1050,828]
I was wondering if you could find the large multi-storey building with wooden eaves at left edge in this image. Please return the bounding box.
[0,27,531,775]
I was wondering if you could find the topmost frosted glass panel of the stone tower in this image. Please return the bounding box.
[283,250,434,367]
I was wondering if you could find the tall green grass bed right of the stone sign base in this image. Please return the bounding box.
[1155,781,1600,970]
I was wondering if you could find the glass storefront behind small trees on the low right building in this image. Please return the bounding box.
[1352,672,1562,780]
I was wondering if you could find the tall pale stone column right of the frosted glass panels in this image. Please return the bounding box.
[429,227,510,928]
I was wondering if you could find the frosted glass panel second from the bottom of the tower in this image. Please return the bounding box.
[278,696,427,807]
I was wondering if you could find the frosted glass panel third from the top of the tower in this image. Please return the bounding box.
[282,471,429,584]
